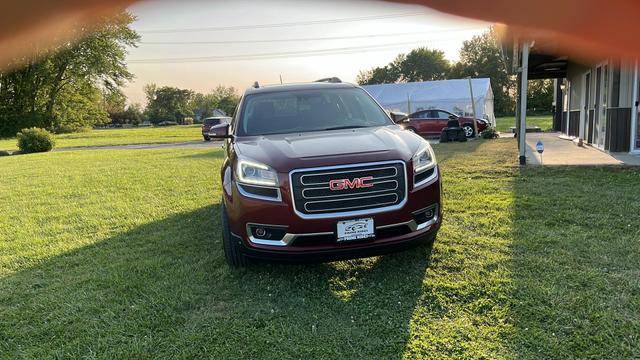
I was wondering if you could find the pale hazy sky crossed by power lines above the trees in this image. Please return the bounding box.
[124,0,490,104]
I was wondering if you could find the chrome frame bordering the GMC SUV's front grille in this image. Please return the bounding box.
[289,160,409,219]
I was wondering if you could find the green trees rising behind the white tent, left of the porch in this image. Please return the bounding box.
[357,29,553,116]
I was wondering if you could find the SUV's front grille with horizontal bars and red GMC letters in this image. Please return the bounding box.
[290,161,407,218]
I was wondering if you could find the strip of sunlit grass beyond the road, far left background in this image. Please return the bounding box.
[0,125,202,150]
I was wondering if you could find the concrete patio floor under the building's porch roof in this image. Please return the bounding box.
[526,133,640,166]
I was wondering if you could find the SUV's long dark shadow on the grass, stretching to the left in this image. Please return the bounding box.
[0,205,431,358]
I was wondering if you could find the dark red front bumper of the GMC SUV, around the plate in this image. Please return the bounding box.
[224,166,442,261]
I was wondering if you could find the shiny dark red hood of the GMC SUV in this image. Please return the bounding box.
[234,125,424,172]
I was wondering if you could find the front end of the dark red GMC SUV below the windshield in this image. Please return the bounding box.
[222,128,442,261]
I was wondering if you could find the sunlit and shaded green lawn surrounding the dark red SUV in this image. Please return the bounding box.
[0,139,640,359]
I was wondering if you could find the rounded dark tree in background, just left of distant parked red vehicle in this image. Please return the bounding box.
[145,84,194,123]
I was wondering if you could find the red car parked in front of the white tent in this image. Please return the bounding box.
[402,109,489,137]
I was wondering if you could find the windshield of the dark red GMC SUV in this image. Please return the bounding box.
[237,88,393,136]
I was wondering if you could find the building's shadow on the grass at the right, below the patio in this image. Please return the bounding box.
[511,167,640,359]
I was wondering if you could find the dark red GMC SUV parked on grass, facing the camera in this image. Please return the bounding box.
[210,78,442,266]
